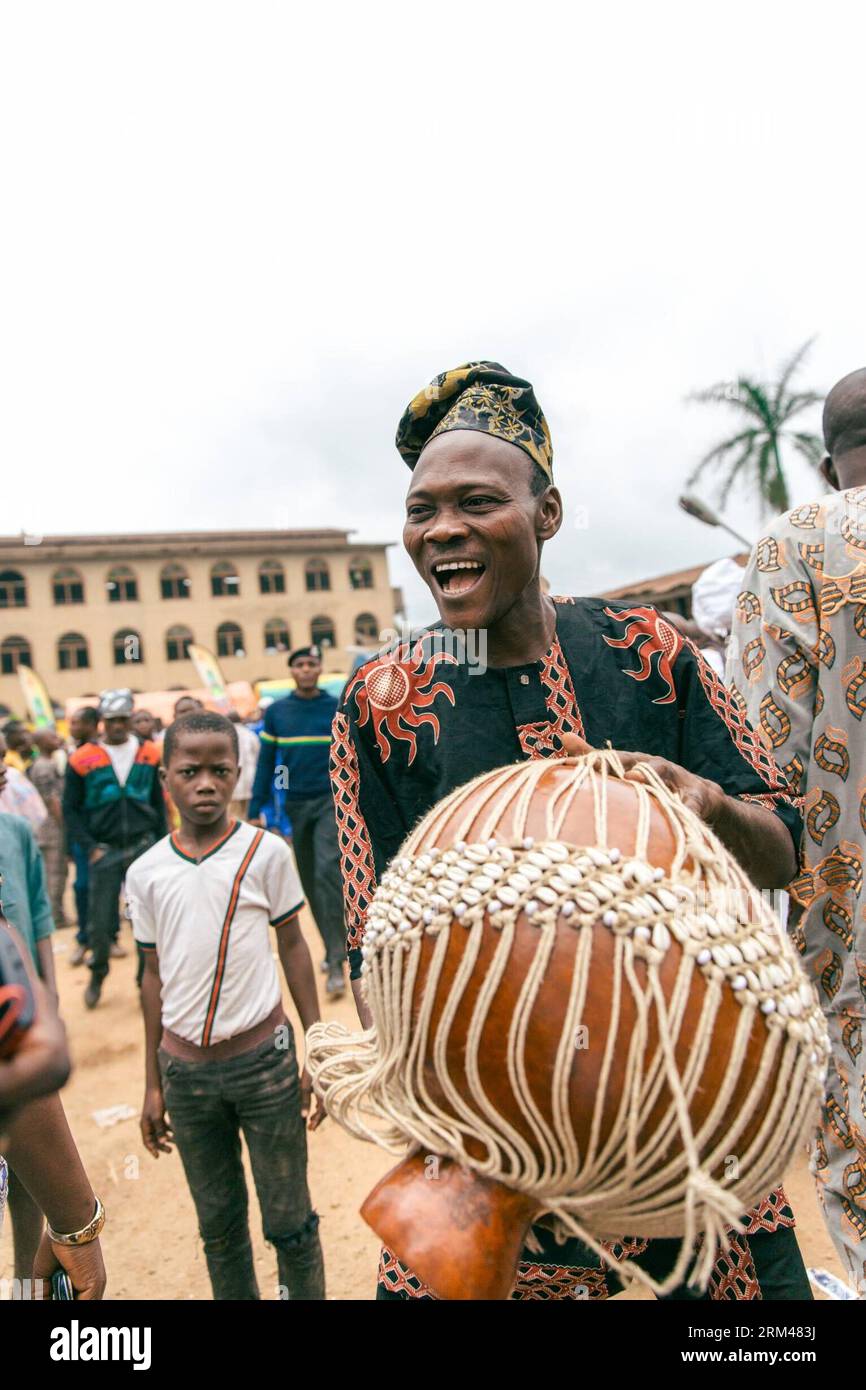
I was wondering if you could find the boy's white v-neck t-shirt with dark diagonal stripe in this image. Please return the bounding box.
[126,820,303,1047]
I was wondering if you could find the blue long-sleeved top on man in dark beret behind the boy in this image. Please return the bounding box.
[249,689,338,816]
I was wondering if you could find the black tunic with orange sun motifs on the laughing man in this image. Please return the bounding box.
[331,598,809,1298]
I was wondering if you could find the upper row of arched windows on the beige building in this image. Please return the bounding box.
[0,559,373,607]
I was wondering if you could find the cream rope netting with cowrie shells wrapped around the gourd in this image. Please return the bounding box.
[307,751,828,1293]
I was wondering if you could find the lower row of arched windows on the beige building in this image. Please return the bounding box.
[0,613,379,676]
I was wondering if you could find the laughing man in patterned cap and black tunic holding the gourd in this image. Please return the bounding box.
[331,363,809,1298]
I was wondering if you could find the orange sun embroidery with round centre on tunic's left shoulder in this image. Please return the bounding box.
[346,641,457,766]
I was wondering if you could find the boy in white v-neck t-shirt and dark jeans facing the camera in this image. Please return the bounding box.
[126,712,324,1300]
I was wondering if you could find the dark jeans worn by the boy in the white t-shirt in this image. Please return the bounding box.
[160,1027,325,1300]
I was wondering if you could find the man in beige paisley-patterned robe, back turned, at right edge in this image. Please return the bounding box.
[728,370,866,1298]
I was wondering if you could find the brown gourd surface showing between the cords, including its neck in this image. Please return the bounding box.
[309,759,828,1298]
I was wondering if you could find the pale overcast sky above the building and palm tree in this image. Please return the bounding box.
[0,0,866,620]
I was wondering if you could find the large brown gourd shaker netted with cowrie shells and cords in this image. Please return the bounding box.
[309,752,828,1298]
